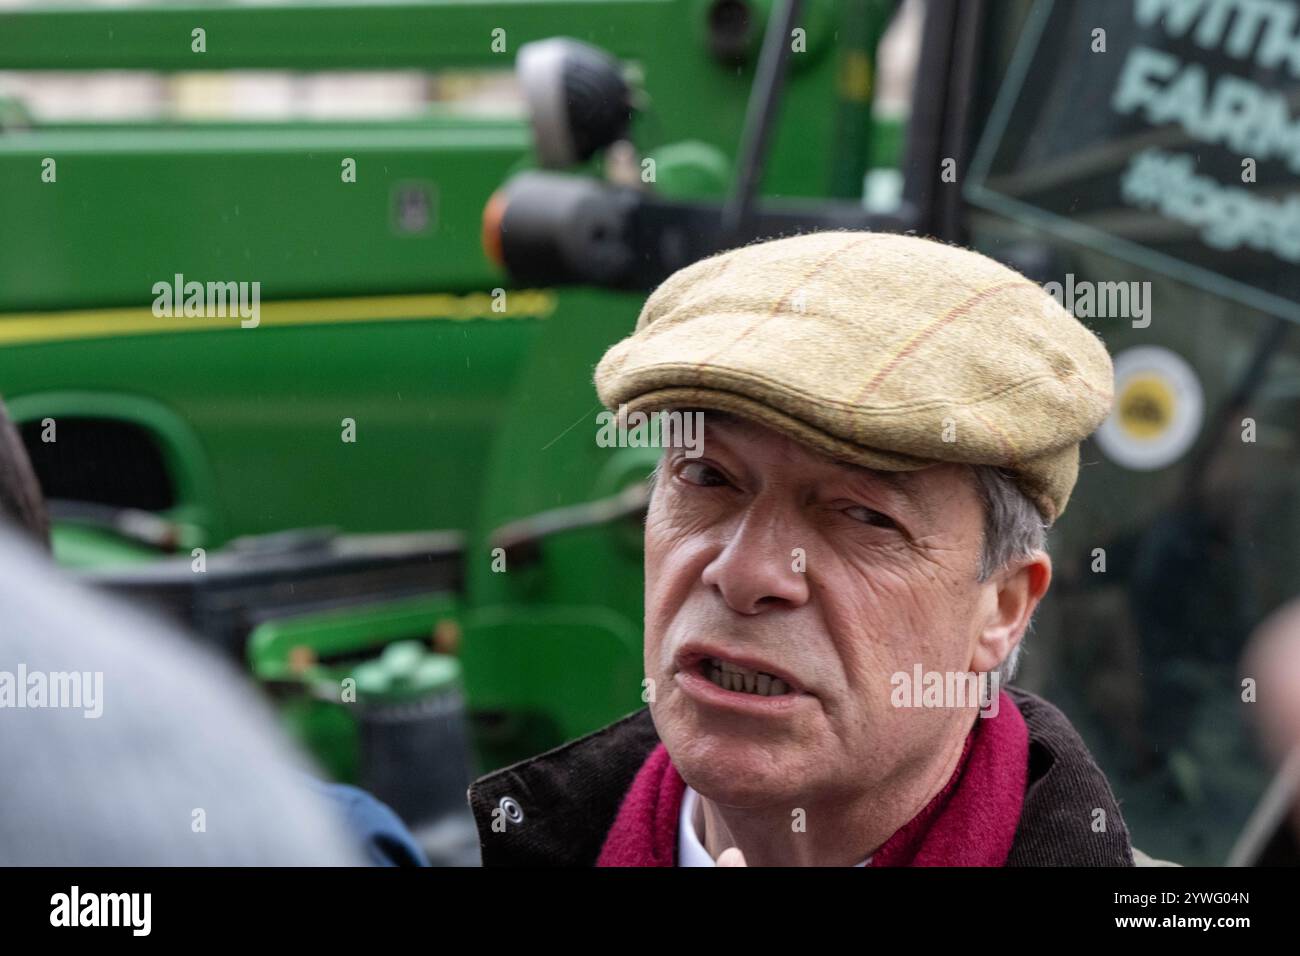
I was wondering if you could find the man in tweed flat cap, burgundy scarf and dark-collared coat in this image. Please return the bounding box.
[469,232,1170,866]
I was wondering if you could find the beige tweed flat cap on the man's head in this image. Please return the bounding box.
[595,232,1113,523]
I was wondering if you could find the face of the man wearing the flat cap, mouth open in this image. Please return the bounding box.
[645,412,1000,806]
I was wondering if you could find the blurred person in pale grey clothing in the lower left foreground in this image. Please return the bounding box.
[0,403,424,866]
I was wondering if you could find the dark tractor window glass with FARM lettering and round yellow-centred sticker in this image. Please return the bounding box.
[965,0,1300,864]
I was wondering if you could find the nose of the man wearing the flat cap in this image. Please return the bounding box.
[702,509,809,614]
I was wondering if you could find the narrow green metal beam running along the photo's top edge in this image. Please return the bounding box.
[0,0,689,70]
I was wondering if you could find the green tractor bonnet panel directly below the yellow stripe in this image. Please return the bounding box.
[0,319,543,545]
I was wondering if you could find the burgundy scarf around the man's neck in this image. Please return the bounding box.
[595,691,1030,866]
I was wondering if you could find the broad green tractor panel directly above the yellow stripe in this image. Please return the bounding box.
[0,122,528,310]
